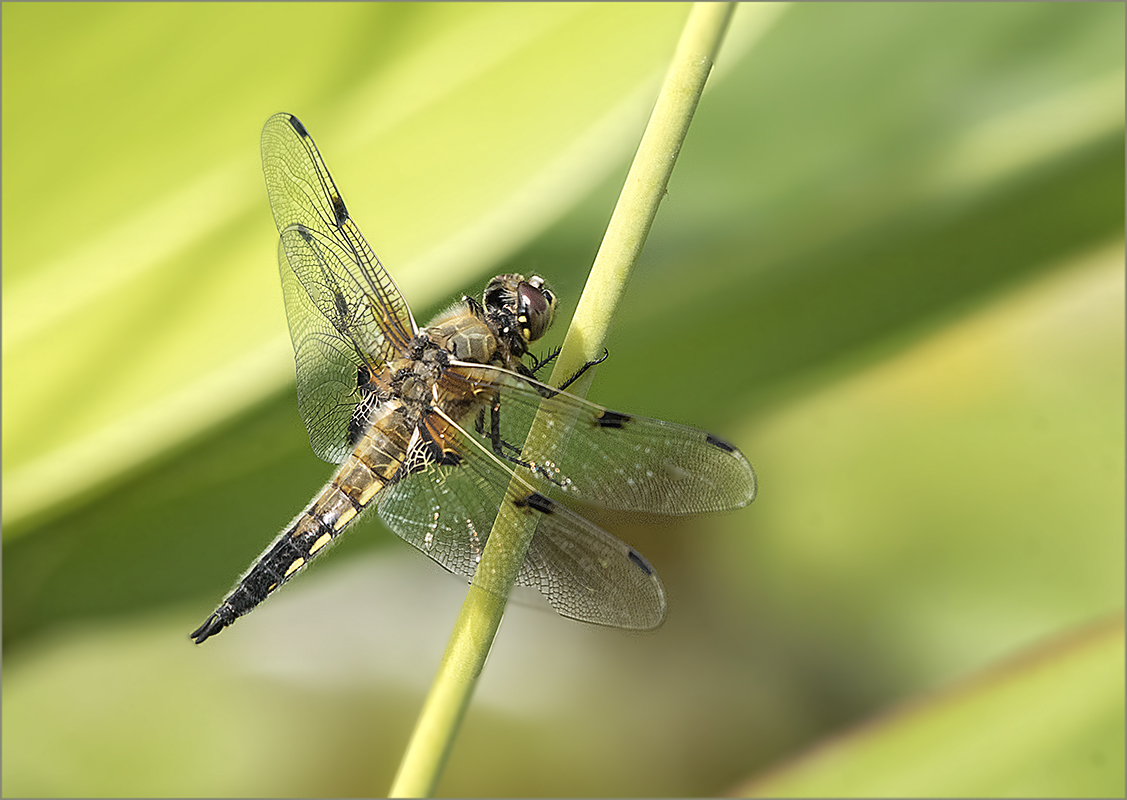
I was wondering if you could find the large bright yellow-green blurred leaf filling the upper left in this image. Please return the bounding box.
[3,5,685,537]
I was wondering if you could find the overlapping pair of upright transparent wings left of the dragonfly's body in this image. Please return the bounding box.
[261,114,418,461]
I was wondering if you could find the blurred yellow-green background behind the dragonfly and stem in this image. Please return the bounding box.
[2,3,1125,797]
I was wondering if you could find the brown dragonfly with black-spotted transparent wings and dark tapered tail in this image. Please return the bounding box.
[190,114,756,643]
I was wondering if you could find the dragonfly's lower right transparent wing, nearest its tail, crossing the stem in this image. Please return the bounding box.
[378,415,665,630]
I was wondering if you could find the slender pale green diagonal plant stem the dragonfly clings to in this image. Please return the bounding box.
[391,3,735,797]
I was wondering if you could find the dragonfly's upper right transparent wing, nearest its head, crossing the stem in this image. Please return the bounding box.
[444,364,756,515]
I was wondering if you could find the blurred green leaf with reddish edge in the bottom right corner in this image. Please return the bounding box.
[735,614,1127,798]
